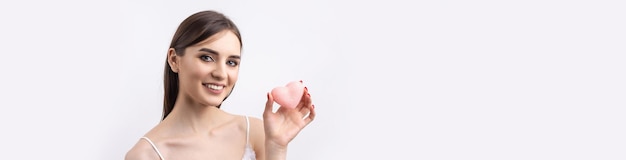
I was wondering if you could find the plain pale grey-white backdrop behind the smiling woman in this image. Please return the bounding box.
[0,0,626,160]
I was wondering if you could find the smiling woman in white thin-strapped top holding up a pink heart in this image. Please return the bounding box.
[125,11,315,160]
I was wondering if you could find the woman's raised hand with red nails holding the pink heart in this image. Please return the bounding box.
[263,87,315,151]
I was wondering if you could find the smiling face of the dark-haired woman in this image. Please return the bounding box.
[176,30,241,106]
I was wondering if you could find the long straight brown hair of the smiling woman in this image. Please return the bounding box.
[161,10,243,120]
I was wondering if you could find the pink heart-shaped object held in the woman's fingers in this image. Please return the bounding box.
[272,81,304,108]
